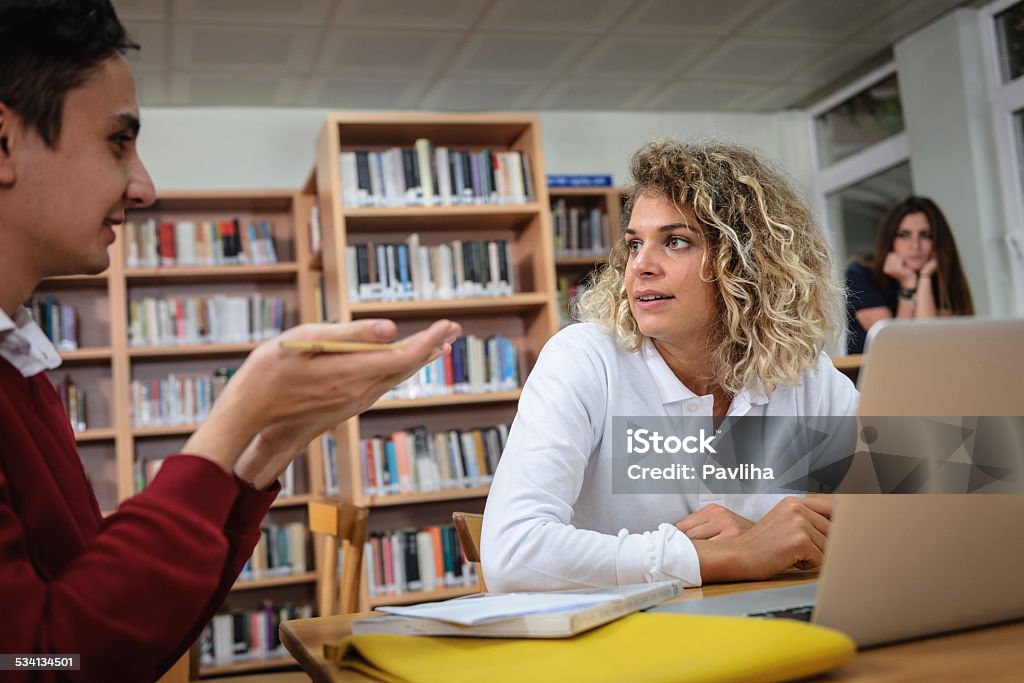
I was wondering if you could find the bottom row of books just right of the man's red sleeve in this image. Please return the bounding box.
[199,602,313,667]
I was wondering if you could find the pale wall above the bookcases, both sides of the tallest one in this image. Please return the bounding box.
[139,108,812,195]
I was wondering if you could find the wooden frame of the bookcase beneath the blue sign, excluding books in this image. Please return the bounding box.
[548,187,623,325]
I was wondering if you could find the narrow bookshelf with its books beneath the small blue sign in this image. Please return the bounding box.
[548,187,623,325]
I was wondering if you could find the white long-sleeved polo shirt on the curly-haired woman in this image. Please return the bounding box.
[480,323,858,592]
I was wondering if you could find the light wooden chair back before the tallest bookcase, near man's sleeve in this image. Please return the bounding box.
[308,499,369,616]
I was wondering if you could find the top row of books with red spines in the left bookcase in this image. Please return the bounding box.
[124,218,278,268]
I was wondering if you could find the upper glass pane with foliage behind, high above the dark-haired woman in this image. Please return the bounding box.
[814,74,903,168]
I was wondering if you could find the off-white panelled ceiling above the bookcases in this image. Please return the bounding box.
[114,0,977,112]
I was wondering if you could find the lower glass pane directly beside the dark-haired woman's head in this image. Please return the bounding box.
[827,162,913,264]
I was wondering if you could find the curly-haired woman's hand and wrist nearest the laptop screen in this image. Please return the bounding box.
[693,498,833,583]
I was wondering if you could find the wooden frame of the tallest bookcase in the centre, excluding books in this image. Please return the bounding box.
[306,114,558,608]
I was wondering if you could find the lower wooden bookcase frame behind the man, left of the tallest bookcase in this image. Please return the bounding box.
[36,190,323,677]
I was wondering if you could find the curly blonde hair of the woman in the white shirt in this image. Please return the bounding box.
[575,140,843,395]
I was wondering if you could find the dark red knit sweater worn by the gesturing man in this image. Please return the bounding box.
[0,358,276,682]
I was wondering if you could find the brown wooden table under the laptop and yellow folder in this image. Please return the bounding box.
[281,571,1024,683]
